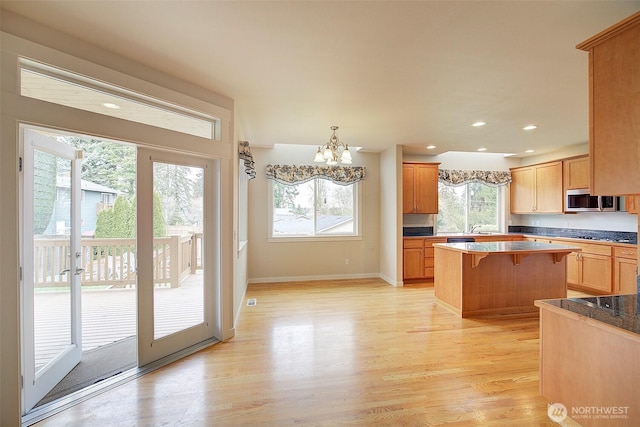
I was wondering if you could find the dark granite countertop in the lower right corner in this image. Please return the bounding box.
[539,294,640,334]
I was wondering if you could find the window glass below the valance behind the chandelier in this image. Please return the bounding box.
[271,178,358,237]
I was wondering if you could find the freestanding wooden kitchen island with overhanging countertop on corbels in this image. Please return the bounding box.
[433,241,580,317]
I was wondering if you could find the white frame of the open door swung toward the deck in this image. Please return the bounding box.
[20,127,82,414]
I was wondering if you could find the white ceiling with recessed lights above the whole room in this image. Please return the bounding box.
[1,0,640,155]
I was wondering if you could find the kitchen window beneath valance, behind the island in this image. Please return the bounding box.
[437,182,505,233]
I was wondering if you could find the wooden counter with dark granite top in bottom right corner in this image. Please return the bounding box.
[536,294,640,427]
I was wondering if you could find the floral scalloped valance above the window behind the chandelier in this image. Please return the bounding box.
[267,165,365,185]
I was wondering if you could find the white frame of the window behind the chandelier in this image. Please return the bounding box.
[267,177,363,243]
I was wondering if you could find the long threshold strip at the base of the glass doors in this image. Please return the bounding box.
[22,338,220,427]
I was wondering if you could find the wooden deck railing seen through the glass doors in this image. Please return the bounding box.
[34,233,202,288]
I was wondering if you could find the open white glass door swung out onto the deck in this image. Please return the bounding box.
[22,128,83,413]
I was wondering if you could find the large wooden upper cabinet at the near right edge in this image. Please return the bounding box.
[577,12,640,195]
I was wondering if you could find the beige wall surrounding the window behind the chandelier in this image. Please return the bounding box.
[248,145,380,283]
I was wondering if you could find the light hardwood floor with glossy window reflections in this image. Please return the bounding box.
[37,280,575,427]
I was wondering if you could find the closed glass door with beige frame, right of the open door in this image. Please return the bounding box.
[137,148,218,366]
